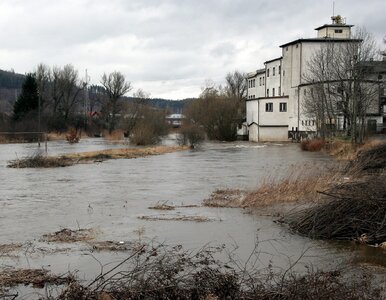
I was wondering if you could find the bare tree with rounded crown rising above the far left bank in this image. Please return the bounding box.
[101,71,132,133]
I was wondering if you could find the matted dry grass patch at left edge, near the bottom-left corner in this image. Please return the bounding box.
[0,269,73,288]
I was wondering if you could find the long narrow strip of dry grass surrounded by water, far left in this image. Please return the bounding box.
[8,146,188,168]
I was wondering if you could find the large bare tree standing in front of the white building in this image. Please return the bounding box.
[303,29,378,143]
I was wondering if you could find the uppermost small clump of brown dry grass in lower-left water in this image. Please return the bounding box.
[41,228,95,243]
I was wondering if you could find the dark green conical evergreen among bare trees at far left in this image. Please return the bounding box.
[13,73,39,120]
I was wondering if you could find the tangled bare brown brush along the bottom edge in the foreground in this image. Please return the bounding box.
[53,243,383,300]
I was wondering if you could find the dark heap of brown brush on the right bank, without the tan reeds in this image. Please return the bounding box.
[284,143,386,244]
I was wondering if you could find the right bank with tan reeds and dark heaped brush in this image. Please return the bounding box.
[204,142,386,247]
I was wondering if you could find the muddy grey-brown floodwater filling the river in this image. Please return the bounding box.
[0,137,386,296]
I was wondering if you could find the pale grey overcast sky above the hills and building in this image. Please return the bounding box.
[0,0,386,99]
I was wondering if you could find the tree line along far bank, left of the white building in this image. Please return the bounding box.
[0,64,247,144]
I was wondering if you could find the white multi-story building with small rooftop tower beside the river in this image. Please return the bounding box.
[246,17,382,142]
